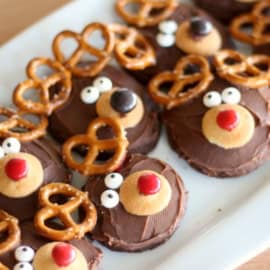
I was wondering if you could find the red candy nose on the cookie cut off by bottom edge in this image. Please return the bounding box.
[52,243,76,267]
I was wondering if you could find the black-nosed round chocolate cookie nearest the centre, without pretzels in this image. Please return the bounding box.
[50,66,160,154]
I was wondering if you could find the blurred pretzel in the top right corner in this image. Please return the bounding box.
[230,0,270,46]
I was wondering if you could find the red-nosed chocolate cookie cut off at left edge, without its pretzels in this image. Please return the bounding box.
[0,138,71,221]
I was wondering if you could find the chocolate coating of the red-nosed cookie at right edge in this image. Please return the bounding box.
[163,77,270,177]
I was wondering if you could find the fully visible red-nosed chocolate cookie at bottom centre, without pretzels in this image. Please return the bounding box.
[85,154,186,252]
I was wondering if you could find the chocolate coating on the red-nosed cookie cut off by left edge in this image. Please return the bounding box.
[0,139,71,221]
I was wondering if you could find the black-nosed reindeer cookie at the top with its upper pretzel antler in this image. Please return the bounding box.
[116,0,234,82]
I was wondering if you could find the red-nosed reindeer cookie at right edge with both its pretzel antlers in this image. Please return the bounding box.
[154,50,270,177]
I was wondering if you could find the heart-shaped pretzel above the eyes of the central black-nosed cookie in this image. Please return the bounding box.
[53,23,115,77]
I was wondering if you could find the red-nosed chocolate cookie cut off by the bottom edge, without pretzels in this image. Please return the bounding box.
[0,222,102,270]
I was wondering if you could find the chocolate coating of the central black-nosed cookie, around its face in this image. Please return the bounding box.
[49,66,160,153]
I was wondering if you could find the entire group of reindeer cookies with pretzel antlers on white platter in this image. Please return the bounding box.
[0,0,270,270]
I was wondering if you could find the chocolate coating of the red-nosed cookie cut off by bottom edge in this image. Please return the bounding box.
[0,222,102,270]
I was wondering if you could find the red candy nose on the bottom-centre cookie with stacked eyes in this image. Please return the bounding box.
[138,174,160,195]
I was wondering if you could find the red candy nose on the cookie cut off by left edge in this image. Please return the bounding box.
[5,158,28,181]
